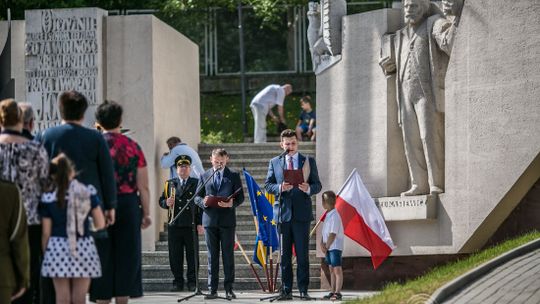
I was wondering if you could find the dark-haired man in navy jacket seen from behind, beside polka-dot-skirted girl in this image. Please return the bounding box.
[36,91,116,304]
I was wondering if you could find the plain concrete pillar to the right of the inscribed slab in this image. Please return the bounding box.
[106,15,200,250]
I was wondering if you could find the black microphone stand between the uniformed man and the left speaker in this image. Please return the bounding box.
[175,168,231,302]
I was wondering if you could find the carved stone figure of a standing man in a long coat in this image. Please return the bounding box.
[380,0,463,196]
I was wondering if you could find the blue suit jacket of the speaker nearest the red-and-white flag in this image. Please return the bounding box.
[264,153,322,223]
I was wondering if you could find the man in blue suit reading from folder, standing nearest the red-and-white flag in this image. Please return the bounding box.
[265,129,322,300]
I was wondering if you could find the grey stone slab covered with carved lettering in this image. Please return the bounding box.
[25,8,107,131]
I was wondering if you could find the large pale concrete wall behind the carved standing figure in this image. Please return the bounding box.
[317,0,540,256]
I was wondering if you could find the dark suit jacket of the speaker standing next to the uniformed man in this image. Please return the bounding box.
[195,167,244,227]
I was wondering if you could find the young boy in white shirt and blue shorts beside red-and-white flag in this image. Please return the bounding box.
[321,191,344,300]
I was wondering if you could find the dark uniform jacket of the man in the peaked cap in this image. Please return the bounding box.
[159,177,202,227]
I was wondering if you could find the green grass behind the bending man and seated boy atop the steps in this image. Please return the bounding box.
[201,94,315,143]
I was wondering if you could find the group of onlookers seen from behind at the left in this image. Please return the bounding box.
[0,91,152,303]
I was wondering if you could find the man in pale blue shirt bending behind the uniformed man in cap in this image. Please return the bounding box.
[161,136,204,179]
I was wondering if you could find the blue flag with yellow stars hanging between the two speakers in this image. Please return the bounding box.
[243,169,279,267]
